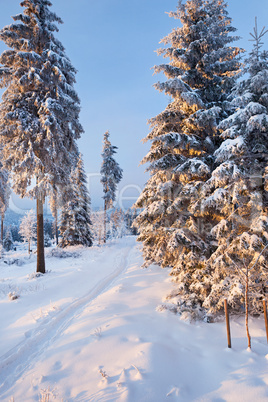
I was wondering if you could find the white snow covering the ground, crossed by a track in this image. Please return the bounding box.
[0,237,268,402]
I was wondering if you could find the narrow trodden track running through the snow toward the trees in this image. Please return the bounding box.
[0,245,133,397]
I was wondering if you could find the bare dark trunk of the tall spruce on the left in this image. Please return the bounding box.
[36,199,46,274]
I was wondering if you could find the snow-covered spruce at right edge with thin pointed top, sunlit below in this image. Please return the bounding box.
[202,20,268,313]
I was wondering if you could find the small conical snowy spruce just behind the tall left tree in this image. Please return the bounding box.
[59,154,93,247]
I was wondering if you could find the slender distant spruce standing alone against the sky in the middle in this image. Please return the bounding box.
[100,131,123,243]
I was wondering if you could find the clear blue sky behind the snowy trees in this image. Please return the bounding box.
[0,0,268,214]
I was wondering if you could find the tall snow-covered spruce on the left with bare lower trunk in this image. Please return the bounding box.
[0,0,83,273]
